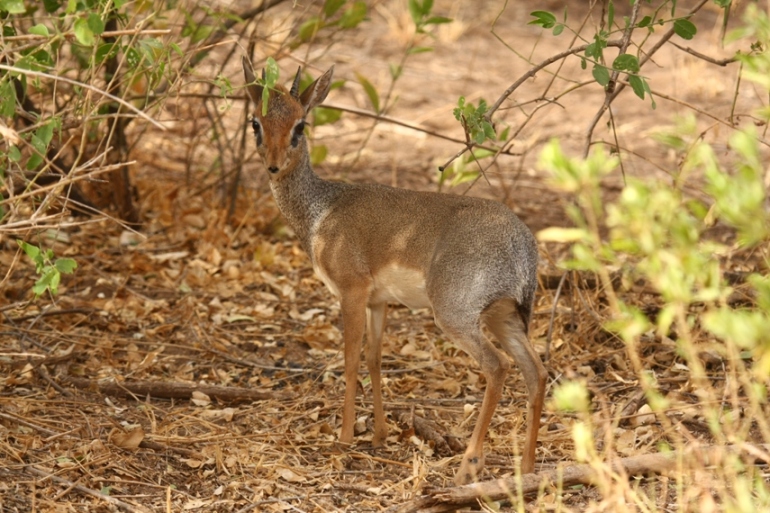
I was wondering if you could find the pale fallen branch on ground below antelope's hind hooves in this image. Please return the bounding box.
[386,444,770,513]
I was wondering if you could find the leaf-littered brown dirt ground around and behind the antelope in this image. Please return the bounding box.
[0,1,760,512]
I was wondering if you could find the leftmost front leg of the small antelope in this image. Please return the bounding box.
[340,291,368,444]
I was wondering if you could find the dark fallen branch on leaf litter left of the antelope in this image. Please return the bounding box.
[61,376,290,403]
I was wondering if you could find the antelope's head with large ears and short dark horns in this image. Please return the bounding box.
[243,57,334,179]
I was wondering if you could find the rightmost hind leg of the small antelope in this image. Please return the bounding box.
[485,303,548,474]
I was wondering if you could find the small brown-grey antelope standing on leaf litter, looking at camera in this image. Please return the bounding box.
[243,57,546,484]
